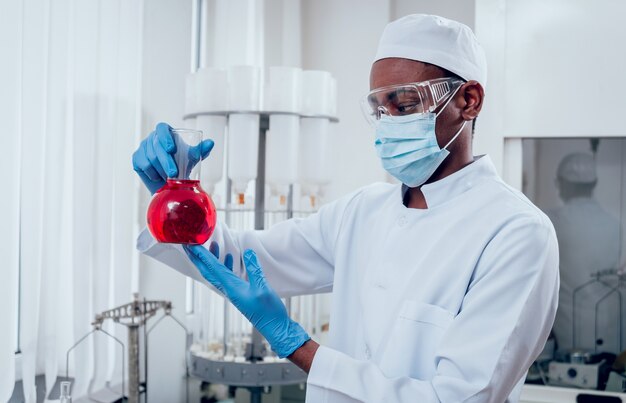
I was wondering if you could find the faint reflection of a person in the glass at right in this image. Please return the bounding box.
[548,152,622,354]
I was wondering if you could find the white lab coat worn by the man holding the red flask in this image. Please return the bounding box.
[138,156,559,403]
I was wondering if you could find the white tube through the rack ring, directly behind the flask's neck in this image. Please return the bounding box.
[195,68,228,194]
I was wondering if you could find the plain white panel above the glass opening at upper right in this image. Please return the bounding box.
[504,0,626,136]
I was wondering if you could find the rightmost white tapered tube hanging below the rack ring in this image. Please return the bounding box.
[298,118,330,208]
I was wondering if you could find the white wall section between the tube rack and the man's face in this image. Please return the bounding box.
[302,0,389,200]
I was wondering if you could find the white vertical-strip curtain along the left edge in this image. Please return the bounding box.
[0,0,143,402]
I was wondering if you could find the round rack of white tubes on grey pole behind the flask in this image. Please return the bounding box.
[183,48,337,402]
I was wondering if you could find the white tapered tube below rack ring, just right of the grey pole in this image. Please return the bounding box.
[265,115,300,207]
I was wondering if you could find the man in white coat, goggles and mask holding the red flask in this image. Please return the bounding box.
[133,15,558,403]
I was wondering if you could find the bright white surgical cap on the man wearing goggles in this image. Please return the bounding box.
[374,14,487,87]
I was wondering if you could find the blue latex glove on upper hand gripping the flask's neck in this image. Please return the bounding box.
[133,123,214,194]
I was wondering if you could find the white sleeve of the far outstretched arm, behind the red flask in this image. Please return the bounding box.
[137,191,360,297]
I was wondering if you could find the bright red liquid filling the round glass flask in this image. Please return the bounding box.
[148,179,216,245]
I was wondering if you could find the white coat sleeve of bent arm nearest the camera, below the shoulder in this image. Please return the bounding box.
[307,218,559,403]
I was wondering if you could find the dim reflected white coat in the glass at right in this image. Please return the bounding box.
[548,197,626,354]
